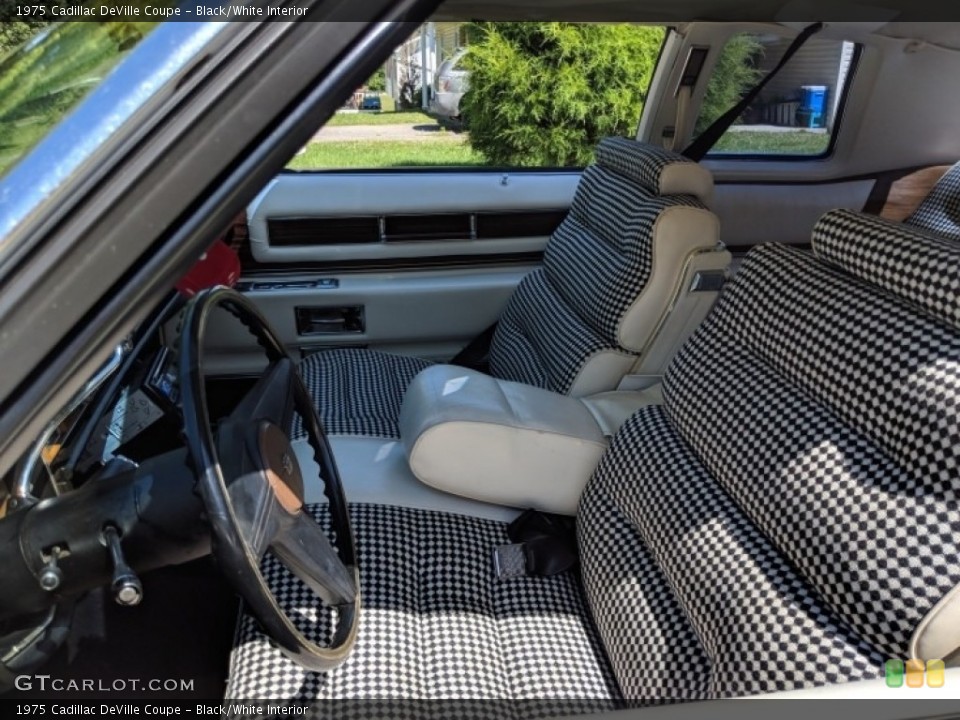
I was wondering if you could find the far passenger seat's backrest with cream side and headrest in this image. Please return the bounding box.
[490,138,729,396]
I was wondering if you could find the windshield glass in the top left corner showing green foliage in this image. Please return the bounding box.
[0,22,157,177]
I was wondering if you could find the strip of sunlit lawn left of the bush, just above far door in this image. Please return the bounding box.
[287,140,485,170]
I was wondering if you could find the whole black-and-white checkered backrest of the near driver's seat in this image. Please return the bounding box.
[578,211,960,700]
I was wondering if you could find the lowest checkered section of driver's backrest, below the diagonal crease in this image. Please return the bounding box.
[579,406,885,701]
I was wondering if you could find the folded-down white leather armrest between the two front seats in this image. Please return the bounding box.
[400,365,607,515]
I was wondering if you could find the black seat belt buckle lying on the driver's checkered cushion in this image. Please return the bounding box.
[493,510,577,579]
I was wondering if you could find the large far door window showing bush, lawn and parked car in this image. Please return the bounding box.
[288,22,665,170]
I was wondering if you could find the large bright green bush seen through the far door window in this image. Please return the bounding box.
[460,23,664,166]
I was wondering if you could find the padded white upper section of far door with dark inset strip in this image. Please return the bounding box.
[248,171,580,264]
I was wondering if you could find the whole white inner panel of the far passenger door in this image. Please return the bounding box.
[201,171,579,374]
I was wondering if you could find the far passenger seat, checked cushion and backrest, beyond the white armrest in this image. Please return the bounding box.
[294,138,729,438]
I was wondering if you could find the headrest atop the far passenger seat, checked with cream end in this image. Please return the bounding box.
[596,137,713,205]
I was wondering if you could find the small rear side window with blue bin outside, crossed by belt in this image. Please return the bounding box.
[694,33,857,157]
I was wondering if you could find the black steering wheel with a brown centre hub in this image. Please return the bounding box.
[180,287,360,671]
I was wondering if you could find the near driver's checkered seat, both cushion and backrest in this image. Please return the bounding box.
[229,211,960,704]
